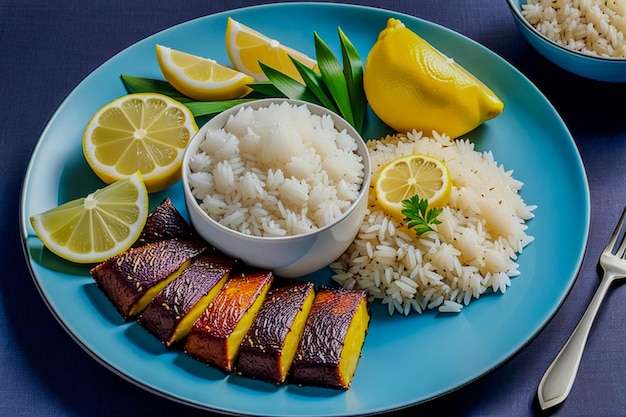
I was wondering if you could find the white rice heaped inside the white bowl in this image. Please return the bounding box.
[189,102,365,237]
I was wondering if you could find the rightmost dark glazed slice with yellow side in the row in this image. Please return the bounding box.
[293,287,370,389]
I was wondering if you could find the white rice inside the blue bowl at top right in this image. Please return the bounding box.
[522,0,626,58]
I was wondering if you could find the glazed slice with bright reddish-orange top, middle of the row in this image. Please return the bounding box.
[184,266,273,372]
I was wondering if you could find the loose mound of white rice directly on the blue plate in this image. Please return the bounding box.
[331,132,535,315]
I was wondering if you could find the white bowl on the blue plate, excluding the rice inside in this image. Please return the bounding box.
[182,99,371,278]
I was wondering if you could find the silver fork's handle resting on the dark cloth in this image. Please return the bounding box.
[537,275,613,410]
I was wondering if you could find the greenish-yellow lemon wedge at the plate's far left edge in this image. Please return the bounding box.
[30,172,148,263]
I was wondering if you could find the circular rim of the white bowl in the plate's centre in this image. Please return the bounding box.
[181,98,372,243]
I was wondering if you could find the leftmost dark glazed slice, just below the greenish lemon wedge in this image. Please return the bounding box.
[90,239,206,320]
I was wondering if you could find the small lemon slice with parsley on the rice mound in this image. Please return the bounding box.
[374,154,452,218]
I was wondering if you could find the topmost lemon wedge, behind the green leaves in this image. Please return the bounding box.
[226,17,317,82]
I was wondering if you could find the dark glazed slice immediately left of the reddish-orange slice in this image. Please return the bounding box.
[138,249,235,346]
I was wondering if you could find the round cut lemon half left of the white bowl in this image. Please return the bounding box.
[83,93,198,192]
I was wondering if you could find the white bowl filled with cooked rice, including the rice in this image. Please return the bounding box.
[182,99,370,277]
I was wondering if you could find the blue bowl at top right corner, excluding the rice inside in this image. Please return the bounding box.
[507,0,626,82]
